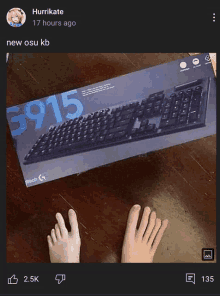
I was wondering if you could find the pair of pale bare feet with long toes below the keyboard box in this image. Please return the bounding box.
[47,205,168,263]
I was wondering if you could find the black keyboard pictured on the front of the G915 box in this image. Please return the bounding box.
[24,77,210,165]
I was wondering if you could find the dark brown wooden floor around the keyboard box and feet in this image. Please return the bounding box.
[7,53,216,263]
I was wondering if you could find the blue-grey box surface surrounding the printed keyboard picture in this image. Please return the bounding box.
[6,53,216,187]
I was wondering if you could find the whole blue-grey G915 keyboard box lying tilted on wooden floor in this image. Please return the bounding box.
[6,53,216,187]
